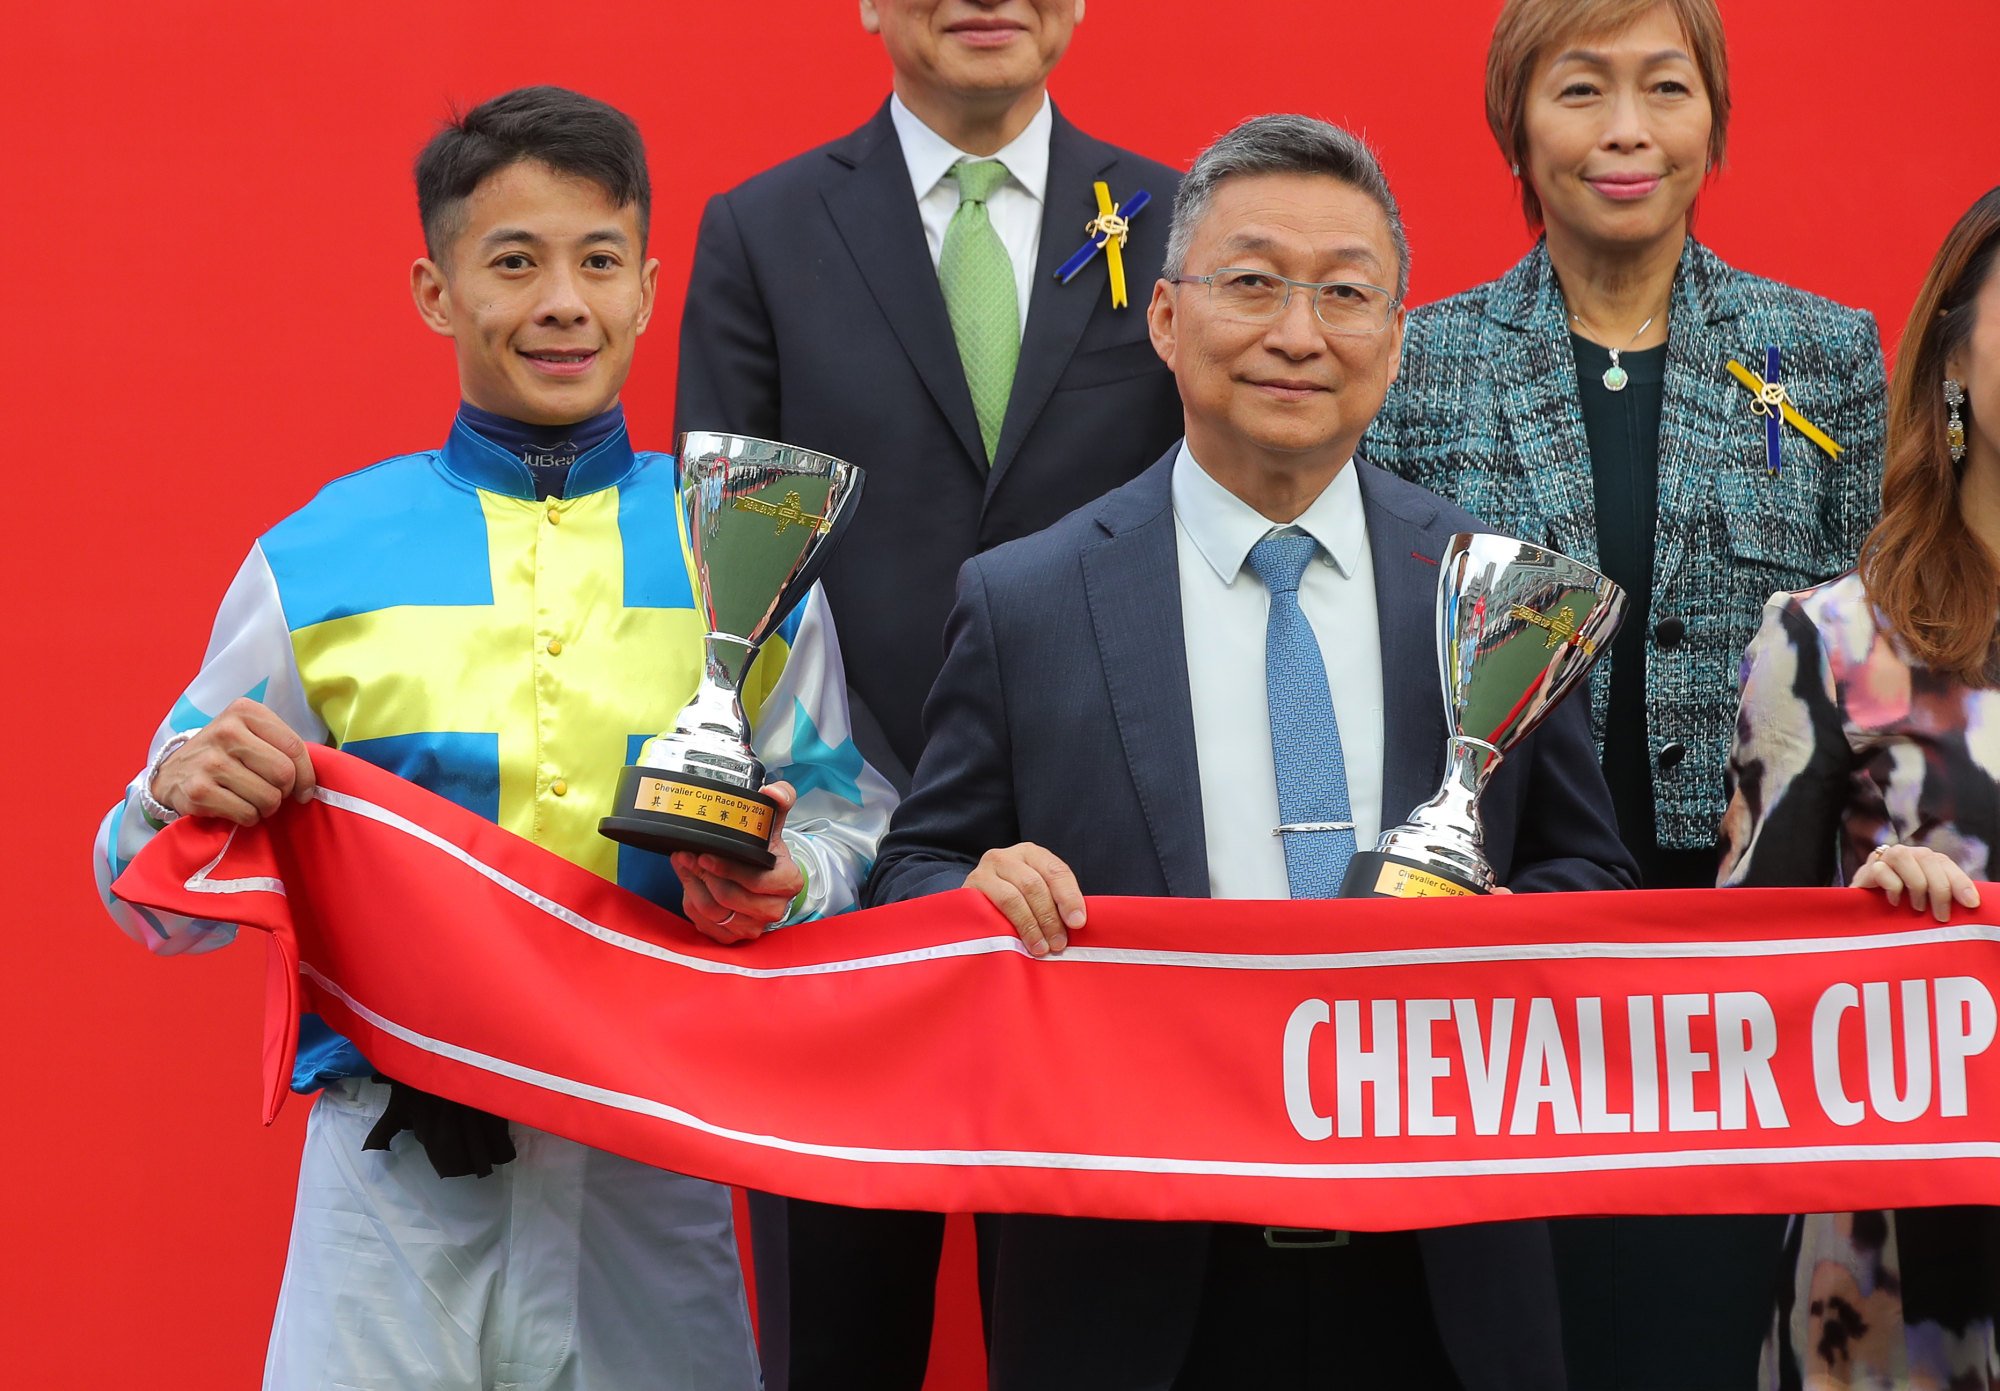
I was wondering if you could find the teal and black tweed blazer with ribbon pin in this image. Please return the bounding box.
[1362,238,1884,849]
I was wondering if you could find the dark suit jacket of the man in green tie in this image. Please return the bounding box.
[674,102,1182,777]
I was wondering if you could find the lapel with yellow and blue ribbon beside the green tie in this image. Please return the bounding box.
[986,112,1128,498]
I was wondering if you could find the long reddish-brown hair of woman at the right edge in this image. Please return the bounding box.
[1860,188,2000,686]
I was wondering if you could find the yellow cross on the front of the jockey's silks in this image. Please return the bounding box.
[292,488,788,879]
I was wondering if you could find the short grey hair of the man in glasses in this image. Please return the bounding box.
[1162,116,1410,304]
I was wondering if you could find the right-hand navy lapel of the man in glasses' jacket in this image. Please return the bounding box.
[1354,460,1448,827]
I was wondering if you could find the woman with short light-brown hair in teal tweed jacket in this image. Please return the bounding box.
[1362,0,1884,887]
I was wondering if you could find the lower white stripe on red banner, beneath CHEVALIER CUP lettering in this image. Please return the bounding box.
[298,961,2000,1179]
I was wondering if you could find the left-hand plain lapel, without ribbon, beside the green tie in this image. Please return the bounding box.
[822,102,986,478]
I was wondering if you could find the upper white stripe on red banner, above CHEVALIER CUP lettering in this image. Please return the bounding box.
[316,787,2000,979]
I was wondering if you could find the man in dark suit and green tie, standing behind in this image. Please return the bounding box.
[676,0,1180,1391]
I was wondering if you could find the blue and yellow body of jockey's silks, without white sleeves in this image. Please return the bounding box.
[262,424,798,891]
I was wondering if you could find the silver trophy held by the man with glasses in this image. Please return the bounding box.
[1340,532,1626,897]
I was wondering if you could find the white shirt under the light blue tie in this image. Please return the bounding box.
[1174,444,1382,899]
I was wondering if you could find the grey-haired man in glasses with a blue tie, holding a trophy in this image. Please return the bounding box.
[868,116,1634,1391]
